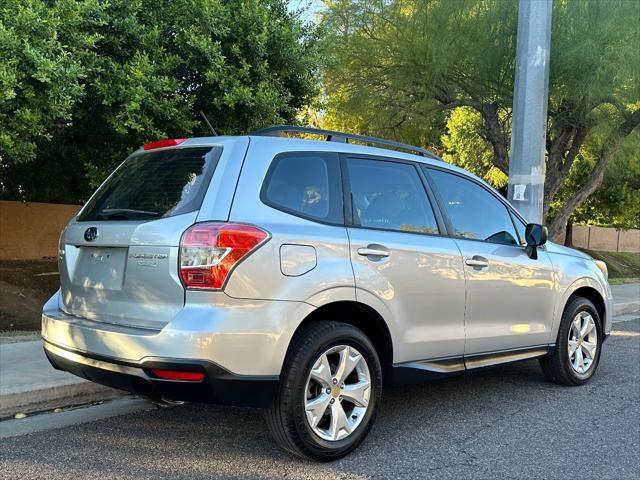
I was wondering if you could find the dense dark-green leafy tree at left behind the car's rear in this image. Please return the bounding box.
[0,0,319,202]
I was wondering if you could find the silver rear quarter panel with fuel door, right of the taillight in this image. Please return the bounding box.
[224,137,355,305]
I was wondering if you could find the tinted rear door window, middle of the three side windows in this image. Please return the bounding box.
[347,159,438,234]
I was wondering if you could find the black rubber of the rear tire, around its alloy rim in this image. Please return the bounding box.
[289,324,382,460]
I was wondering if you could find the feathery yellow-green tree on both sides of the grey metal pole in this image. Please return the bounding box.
[324,0,640,238]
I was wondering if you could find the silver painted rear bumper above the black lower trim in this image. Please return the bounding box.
[42,291,315,378]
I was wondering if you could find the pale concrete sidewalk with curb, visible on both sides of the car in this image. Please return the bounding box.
[0,283,640,418]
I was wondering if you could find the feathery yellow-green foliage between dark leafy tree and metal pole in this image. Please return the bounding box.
[324,0,517,133]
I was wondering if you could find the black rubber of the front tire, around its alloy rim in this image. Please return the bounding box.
[557,298,603,385]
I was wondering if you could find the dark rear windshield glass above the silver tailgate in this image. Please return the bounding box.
[78,147,222,222]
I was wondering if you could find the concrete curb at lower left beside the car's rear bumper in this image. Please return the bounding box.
[0,379,123,418]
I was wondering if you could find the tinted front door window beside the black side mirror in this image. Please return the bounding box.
[429,169,519,245]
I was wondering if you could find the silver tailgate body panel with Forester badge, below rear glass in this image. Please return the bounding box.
[60,212,196,329]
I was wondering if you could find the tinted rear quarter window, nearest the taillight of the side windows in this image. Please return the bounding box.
[262,153,343,224]
